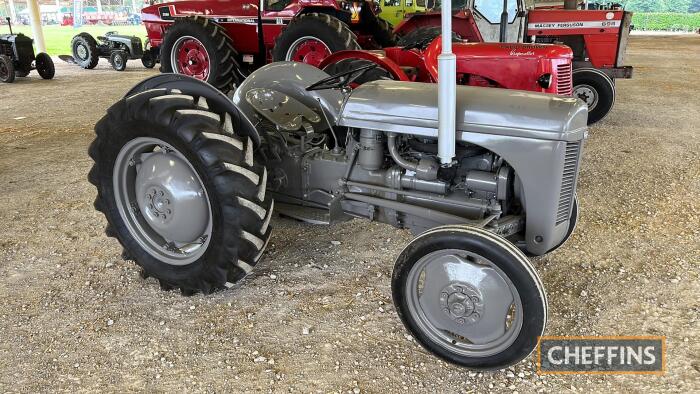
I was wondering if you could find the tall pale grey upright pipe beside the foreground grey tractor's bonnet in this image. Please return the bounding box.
[438,0,457,166]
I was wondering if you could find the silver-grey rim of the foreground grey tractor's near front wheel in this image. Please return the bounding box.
[405,249,523,357]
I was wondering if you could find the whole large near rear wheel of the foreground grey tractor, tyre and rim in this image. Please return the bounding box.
[88,89,273,295]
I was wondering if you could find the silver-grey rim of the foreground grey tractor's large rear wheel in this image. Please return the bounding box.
[113,137,212,266]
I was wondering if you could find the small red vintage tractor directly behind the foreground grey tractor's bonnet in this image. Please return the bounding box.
[319,27,573,96]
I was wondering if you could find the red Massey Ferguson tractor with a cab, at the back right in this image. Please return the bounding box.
[394,0,632,123]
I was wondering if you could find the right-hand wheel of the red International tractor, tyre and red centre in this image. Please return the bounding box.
[272,12,360,66]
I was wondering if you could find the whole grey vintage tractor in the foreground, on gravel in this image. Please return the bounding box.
[89,62,587,369]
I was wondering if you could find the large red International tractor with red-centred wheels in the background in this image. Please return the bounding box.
[142,0,395,91]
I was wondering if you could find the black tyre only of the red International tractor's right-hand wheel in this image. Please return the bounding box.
[272,12,360,62]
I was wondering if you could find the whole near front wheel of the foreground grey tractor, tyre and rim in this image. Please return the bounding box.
[391,225,547,370]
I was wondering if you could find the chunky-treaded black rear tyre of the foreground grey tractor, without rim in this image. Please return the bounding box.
[88,89,273,295]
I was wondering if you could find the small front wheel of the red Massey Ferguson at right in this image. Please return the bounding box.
[573,68,615,125]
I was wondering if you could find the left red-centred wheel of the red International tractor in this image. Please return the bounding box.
[160,15,241,93]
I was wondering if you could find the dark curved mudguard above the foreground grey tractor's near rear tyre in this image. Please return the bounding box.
[124,74,260,148]
